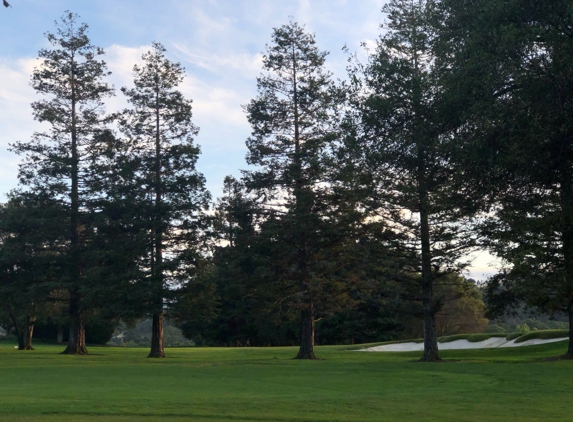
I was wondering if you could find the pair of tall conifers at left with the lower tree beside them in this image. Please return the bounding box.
[1,13,209,357]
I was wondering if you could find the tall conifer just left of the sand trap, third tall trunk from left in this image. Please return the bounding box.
[245,21,359,359]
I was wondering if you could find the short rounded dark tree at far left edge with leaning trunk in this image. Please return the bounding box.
[0,193,66,350]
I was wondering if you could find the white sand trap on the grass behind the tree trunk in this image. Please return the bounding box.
[360,337,568,352]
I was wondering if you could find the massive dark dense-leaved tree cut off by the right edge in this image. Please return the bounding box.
[441,0,573,358]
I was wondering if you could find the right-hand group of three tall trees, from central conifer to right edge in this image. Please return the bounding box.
[198,0,573,361]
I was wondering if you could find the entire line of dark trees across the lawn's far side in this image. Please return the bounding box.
[0,0,573,361]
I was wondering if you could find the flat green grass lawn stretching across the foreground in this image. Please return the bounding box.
[0,342,573,421]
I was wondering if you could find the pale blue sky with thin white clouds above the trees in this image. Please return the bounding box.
[0,0,500,279]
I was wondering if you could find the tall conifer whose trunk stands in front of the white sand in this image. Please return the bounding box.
[349,0,476,362]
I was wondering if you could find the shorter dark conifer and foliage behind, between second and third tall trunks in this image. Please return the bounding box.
[179,176,298,346]
